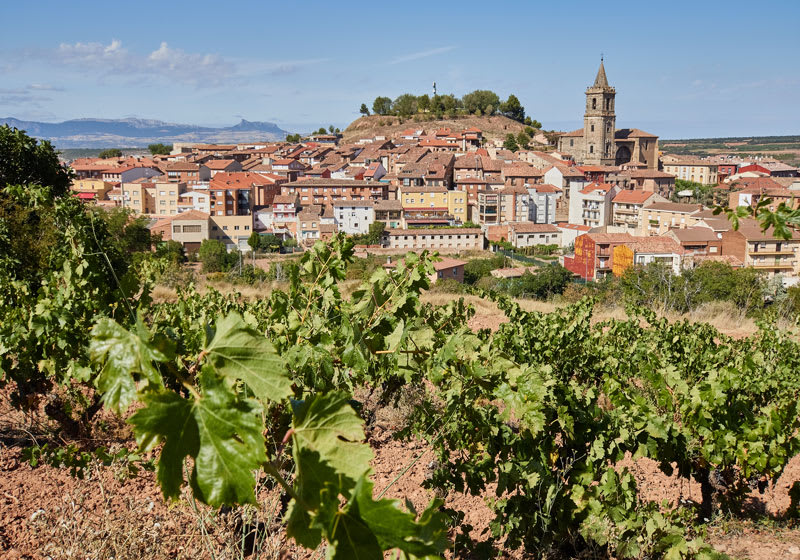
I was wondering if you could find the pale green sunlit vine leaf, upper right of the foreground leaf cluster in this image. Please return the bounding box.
[204,313,292,402]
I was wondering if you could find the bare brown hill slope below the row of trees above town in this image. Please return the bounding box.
[342,115,525,142]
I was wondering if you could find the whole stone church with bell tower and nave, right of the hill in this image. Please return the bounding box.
[558,59,658,169]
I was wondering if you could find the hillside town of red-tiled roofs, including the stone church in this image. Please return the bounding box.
[70,62,800,283]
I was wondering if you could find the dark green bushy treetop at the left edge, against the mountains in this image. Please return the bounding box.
[0,125,73,197]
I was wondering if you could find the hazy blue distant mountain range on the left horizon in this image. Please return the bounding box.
[0,117,287,148]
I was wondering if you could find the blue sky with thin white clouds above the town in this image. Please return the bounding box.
[0,0,800,138]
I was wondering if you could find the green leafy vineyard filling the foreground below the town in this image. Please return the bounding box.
[0,130,800,559]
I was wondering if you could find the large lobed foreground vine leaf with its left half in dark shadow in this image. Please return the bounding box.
[128,366,267,506]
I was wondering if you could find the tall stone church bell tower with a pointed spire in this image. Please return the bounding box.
[583,57,617,165]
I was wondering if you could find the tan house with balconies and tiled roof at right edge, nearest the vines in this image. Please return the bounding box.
[721,220,800,276]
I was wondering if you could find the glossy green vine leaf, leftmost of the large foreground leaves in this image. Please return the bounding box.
[89,317,175,413]
